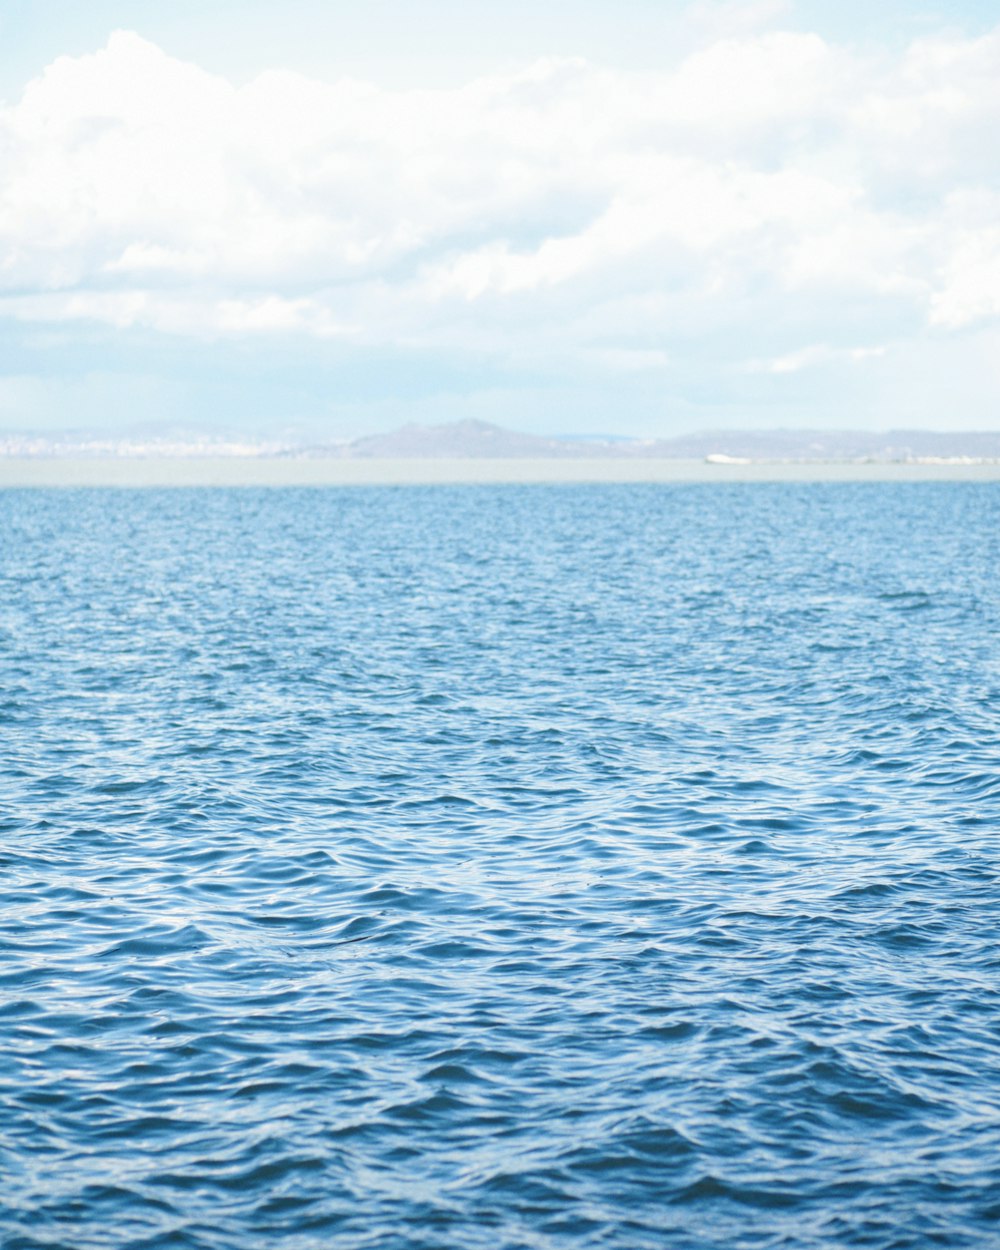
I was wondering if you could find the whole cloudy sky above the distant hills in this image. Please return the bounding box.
[0,0,1000,440]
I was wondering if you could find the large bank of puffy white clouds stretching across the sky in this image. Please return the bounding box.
[0,23,1000,373]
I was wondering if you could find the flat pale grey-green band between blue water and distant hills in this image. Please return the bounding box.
[0,456,1000,489]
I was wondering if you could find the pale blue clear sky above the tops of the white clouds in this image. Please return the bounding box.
[7,0,999,93]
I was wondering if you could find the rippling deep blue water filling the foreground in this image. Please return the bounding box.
[0,484,1000,1250]
